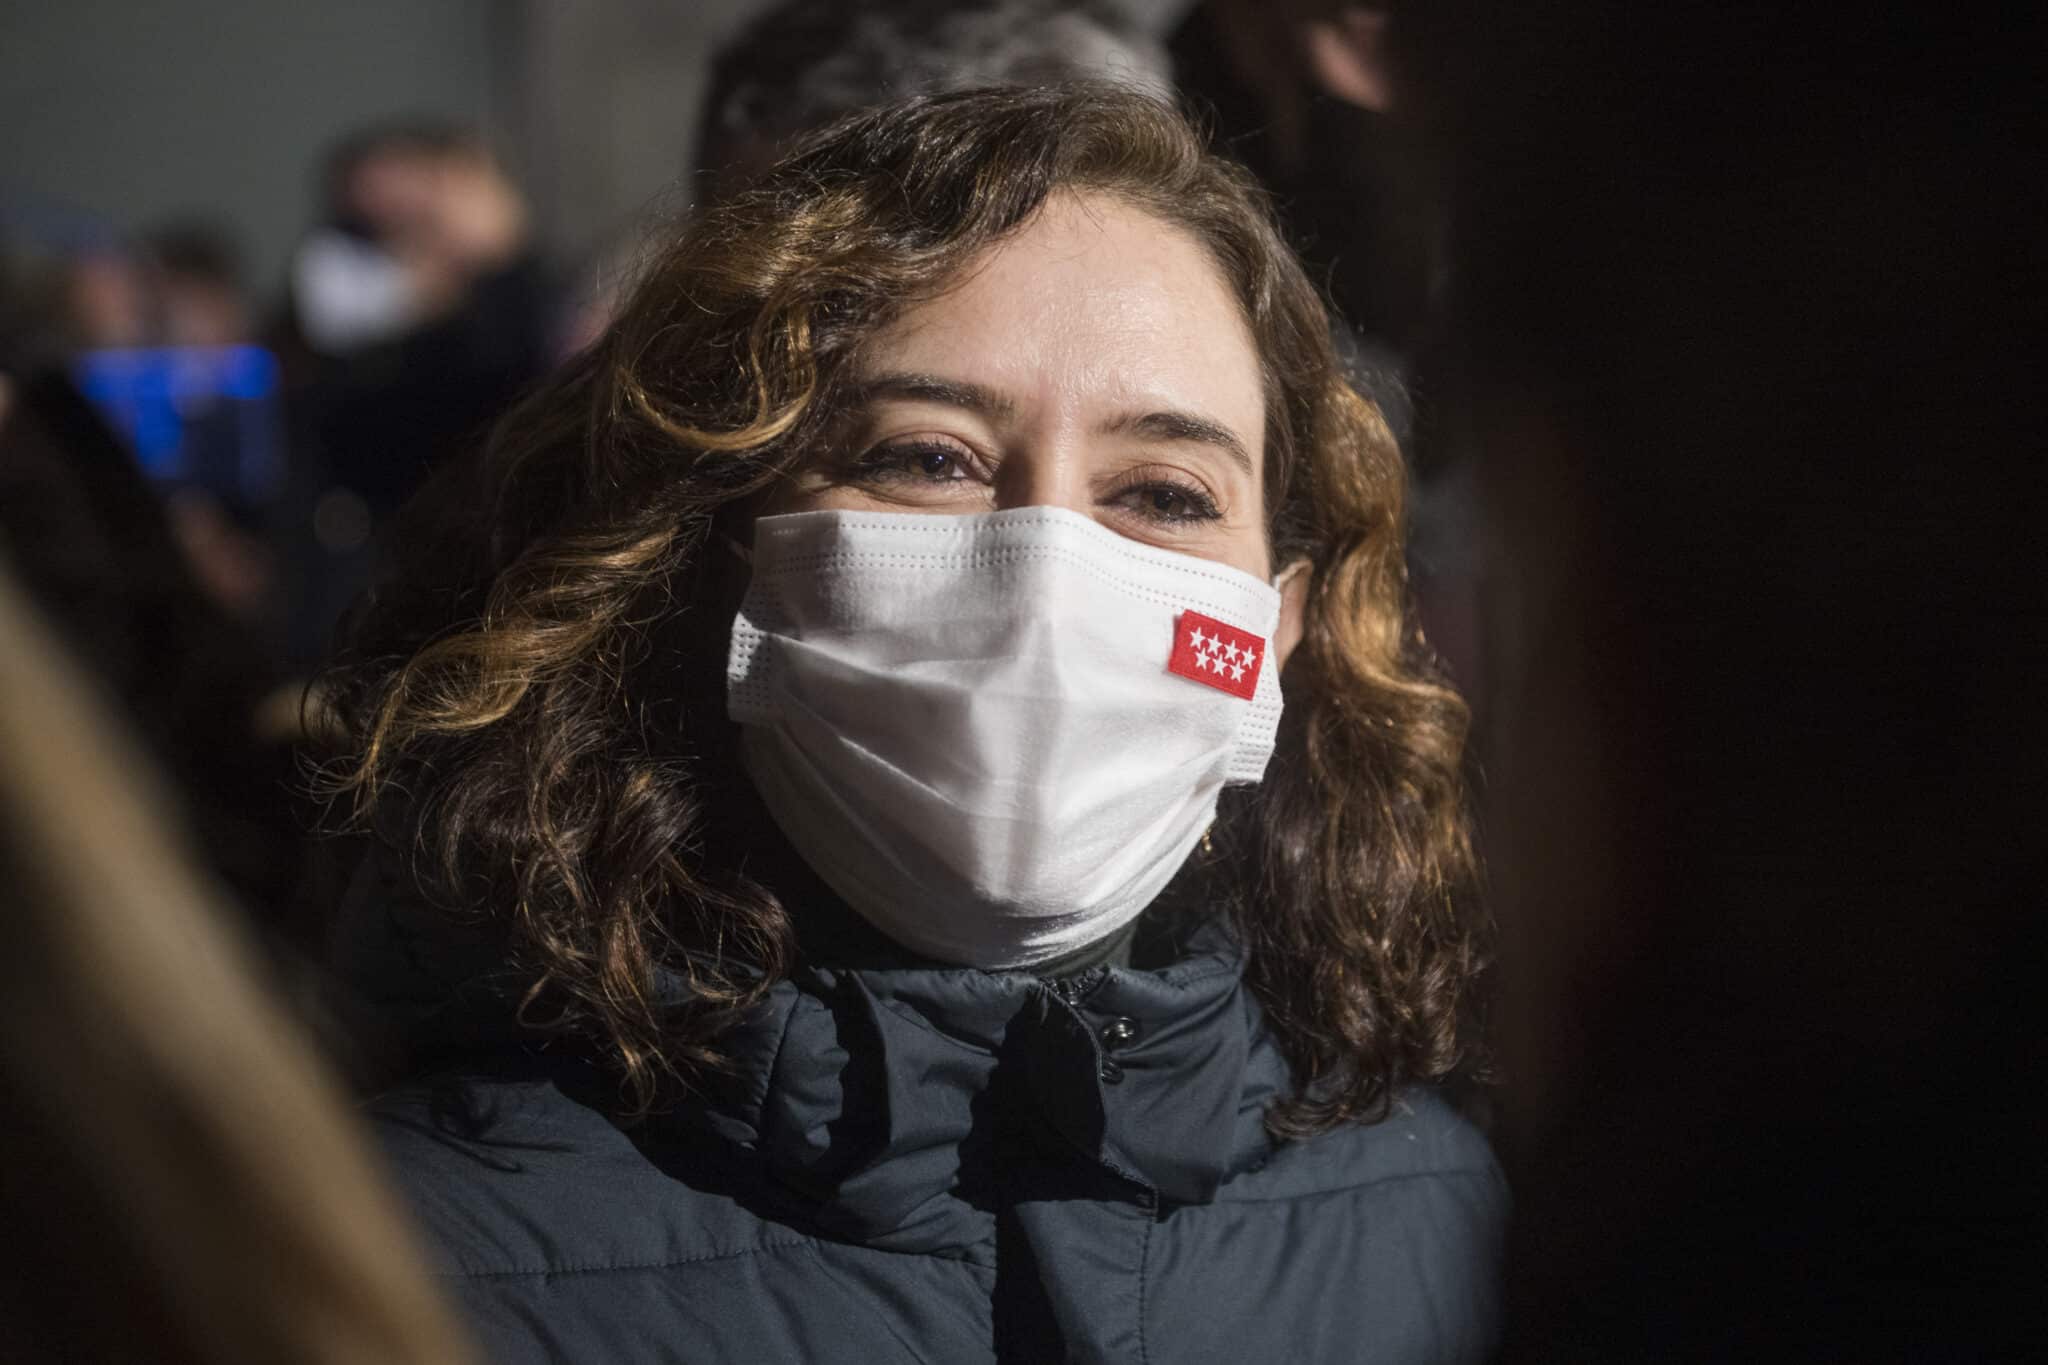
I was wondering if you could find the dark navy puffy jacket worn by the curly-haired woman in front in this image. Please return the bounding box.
[356,879,1505,1365]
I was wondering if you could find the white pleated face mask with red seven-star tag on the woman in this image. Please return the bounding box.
[727,508,1280,968]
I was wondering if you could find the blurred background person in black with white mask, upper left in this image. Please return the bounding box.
[274,121,561,659]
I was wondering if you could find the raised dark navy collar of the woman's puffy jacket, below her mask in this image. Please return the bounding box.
[662,921,1284,1248]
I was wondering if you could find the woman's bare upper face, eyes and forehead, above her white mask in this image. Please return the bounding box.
[768,196,1274,579]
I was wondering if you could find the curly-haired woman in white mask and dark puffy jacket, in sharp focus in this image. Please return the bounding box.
[338,88,1503,1361]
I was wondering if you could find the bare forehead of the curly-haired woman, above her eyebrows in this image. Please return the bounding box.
[862,194,1264,454]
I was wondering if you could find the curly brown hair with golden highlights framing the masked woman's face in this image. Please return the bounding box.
[328,86,1483,1136]
